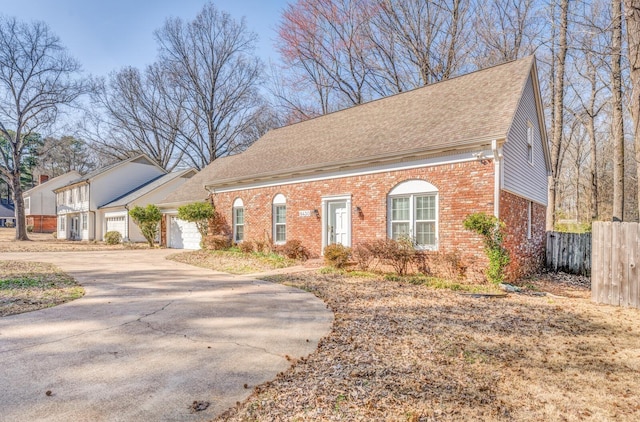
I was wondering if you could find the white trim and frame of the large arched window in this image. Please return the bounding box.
[387,180,440,251]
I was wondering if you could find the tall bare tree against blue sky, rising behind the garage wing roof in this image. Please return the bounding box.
[155,3,262,168]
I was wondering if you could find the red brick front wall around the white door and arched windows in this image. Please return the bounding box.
[213,161,494,259]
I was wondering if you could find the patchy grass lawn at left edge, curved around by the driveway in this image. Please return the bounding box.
[0,261,84,317]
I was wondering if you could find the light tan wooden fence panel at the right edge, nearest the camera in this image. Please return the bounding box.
[591,222,640,308]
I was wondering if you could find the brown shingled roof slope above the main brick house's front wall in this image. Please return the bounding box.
[205,56,535,188]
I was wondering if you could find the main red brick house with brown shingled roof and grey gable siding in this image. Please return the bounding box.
[205,57,549,278]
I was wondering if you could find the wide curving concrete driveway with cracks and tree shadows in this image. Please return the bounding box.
[0,250,333,421]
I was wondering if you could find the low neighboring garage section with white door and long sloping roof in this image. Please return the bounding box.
[99,169,196,242]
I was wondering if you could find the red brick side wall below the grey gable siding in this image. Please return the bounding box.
[500,190,546,280]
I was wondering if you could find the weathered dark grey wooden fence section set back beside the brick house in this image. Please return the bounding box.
[546,232,591,275]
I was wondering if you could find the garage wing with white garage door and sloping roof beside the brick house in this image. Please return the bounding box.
[156,157,230,249]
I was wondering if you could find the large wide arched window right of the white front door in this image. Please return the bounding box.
[388,180,438,249]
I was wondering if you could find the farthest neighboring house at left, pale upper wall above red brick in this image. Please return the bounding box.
[22,170,81,233]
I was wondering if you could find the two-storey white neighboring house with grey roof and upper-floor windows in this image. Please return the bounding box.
[54,154,167,240]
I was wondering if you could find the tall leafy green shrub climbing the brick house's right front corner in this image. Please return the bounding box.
[463,212,510,284]
